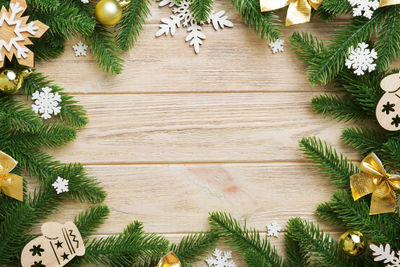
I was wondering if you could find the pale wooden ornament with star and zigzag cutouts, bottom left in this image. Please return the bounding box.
[21,222,85,267]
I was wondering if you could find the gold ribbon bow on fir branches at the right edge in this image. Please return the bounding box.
[350,153,400,215]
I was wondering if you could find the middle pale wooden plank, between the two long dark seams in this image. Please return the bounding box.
[47,93,359,164]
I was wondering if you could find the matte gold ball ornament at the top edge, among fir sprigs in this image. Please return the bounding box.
[94,0,122,26]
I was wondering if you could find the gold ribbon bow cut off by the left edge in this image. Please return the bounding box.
[0,151,23,201]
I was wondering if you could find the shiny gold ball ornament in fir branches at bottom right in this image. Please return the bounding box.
[339,231,367,256]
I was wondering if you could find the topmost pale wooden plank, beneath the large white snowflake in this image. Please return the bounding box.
[38,23,344,94]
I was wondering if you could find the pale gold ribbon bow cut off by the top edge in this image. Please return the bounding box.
[260,0,324,26]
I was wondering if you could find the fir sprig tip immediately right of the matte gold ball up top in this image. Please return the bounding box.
[116,0,150,51]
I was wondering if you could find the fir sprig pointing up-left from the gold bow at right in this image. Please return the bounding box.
[300,137,356,189]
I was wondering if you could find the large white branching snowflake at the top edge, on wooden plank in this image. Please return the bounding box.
[156,0,233,54]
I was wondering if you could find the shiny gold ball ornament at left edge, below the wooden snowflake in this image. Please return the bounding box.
[0,69,32,94]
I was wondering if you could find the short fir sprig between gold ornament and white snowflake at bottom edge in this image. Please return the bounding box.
[170,232,218,266]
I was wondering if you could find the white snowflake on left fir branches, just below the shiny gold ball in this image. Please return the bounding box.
[32,87,61,119]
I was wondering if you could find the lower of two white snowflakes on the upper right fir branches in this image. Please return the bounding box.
[346,43,378,76]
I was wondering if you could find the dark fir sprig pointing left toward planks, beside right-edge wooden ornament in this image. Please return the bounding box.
[311,95,367,122]
